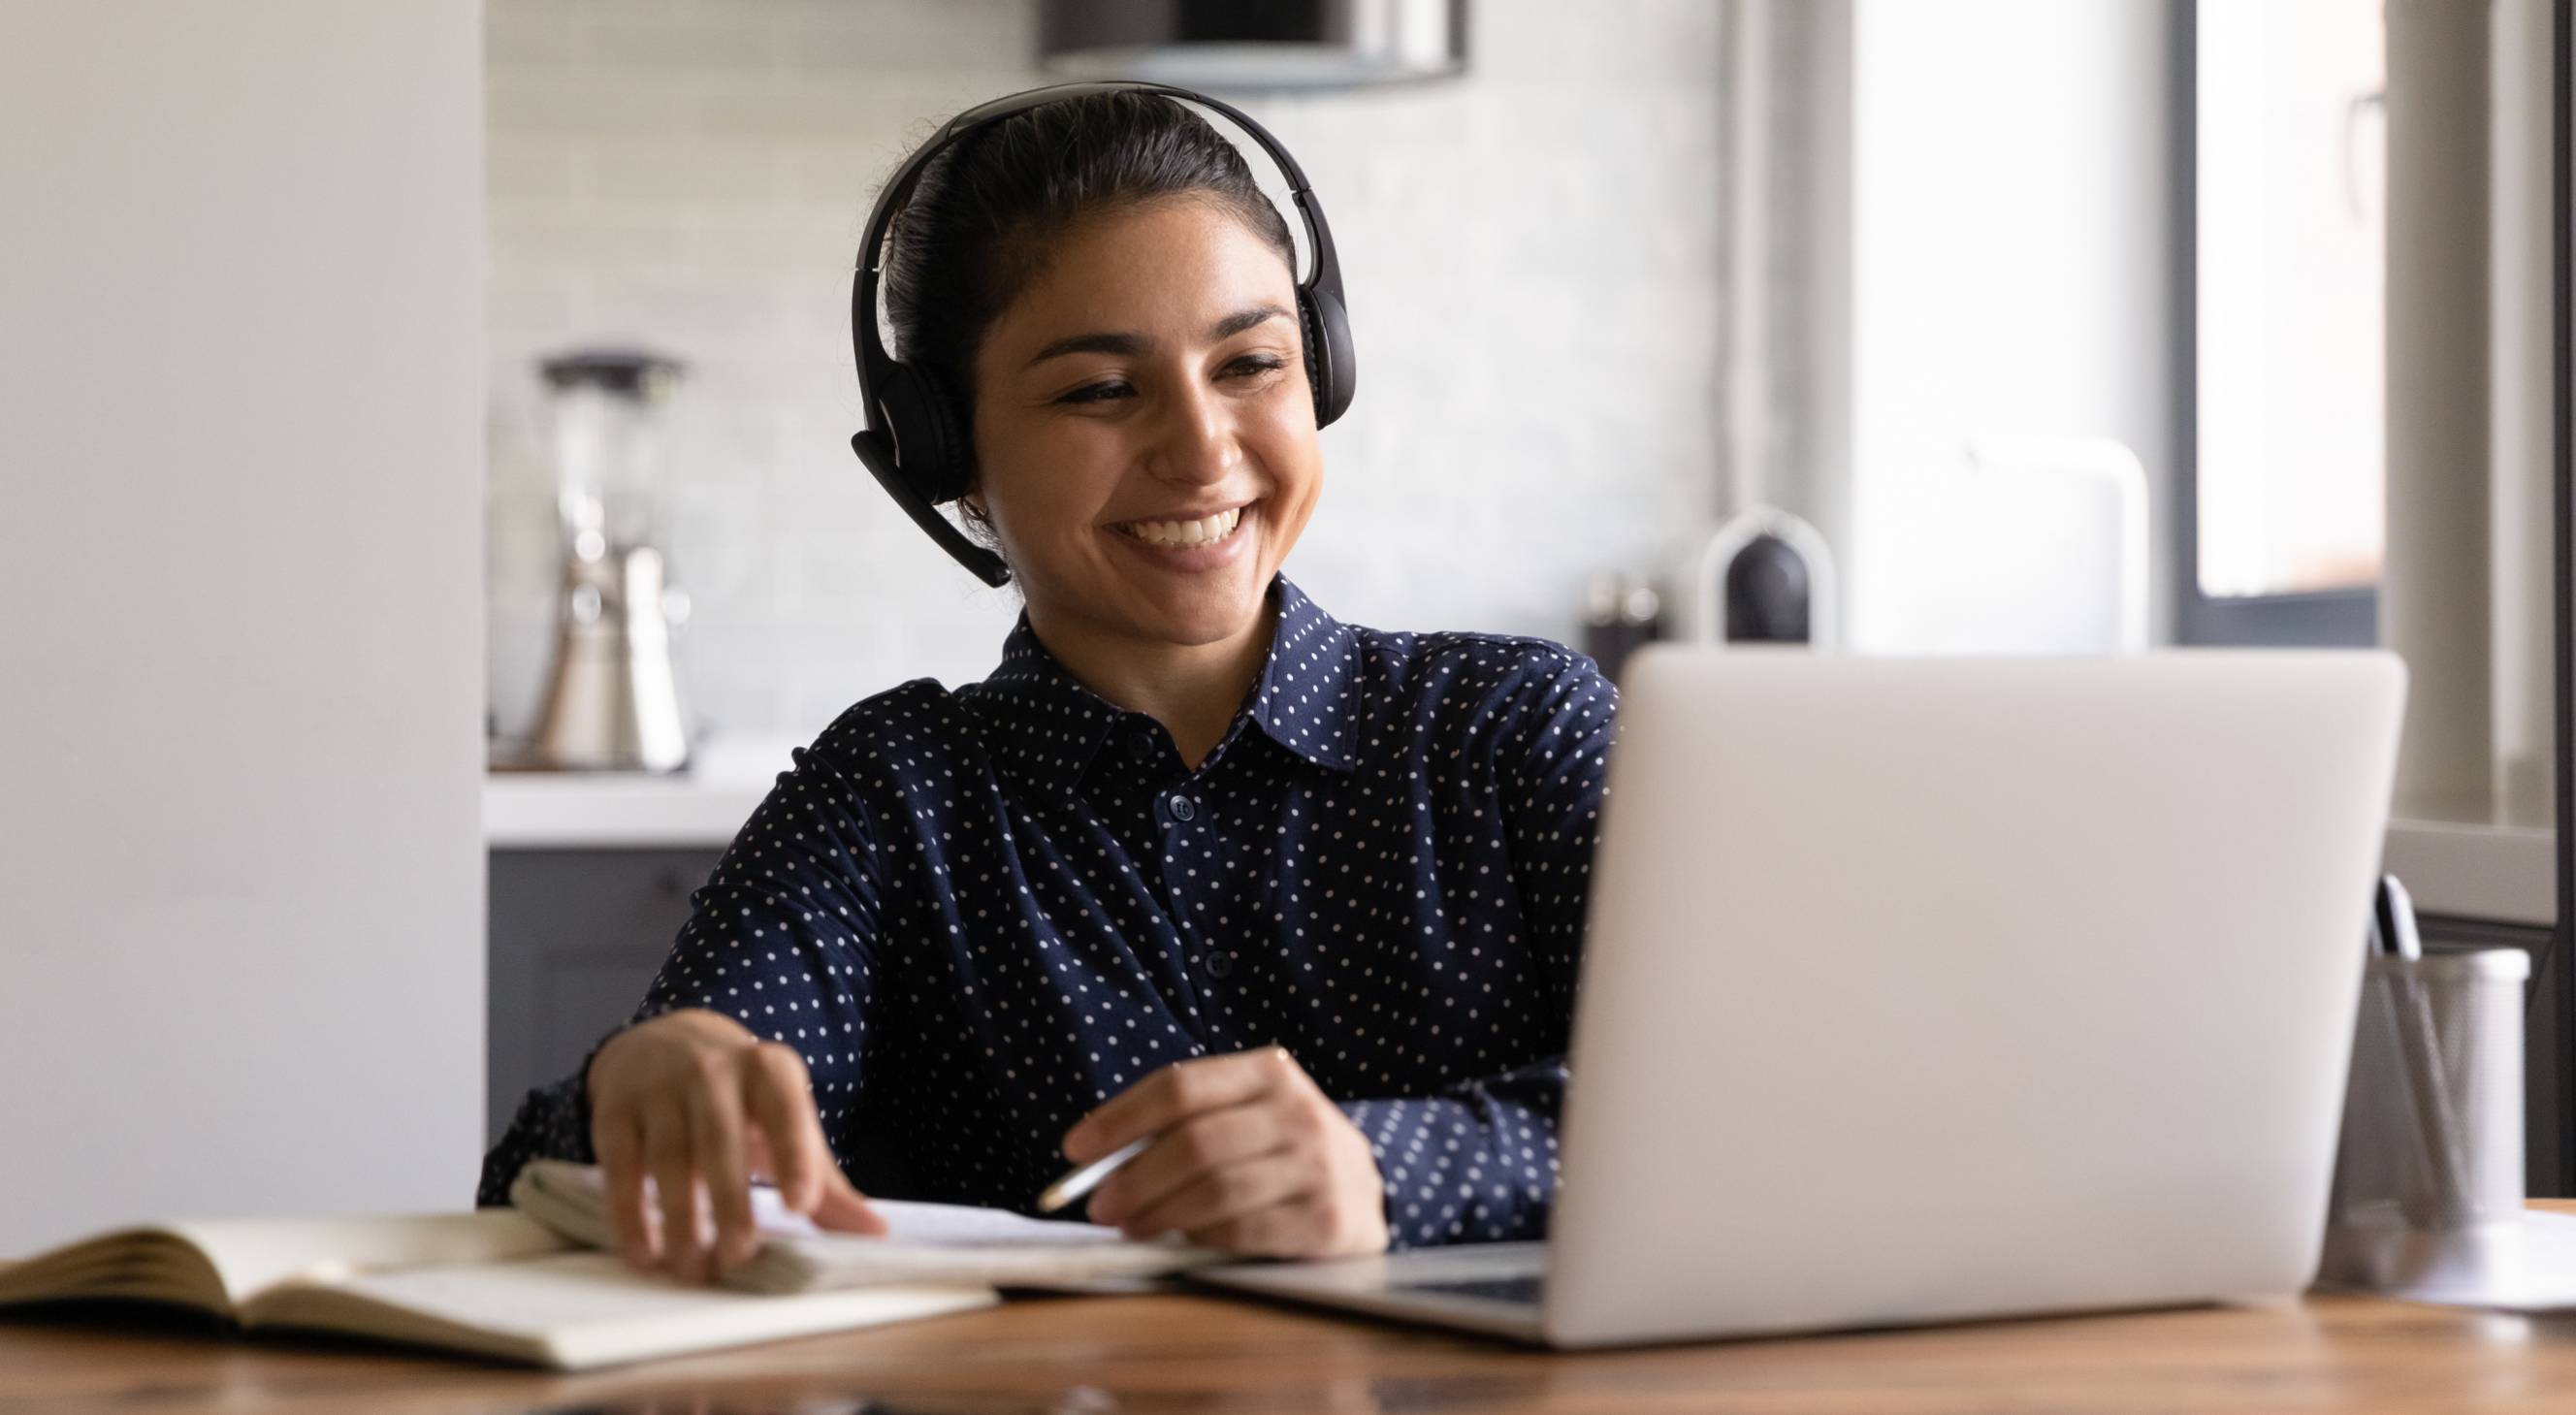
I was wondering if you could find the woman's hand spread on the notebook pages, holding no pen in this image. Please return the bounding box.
[585,1008,886,1281]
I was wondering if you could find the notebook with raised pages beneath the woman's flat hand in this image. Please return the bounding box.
[510,1160,1226,1294]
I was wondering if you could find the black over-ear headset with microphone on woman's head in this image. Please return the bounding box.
[850,82,1360,585]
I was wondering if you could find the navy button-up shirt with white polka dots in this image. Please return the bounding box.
[482,575,1618,1247]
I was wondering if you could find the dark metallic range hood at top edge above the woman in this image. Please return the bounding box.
[1038,0,1465,93]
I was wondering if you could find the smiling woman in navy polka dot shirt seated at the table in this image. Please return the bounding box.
[482,85,1618,1275]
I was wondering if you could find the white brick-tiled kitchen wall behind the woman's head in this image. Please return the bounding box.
[487,0,1721,737]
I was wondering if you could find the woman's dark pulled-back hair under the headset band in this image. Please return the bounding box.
[884,90,1296,549]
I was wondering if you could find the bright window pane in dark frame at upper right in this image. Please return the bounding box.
[2176,0,2385,644]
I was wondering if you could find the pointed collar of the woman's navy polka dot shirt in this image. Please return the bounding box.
[969,575,1360,794]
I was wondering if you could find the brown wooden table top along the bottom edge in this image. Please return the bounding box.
[15,1221,2576,1415]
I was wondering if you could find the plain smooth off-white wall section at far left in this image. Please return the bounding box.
[0,0,484,1255]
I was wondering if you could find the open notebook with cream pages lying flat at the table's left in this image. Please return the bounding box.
[0,1208,997,1371]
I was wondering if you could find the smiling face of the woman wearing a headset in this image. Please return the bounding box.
[974,201,1322,657]
